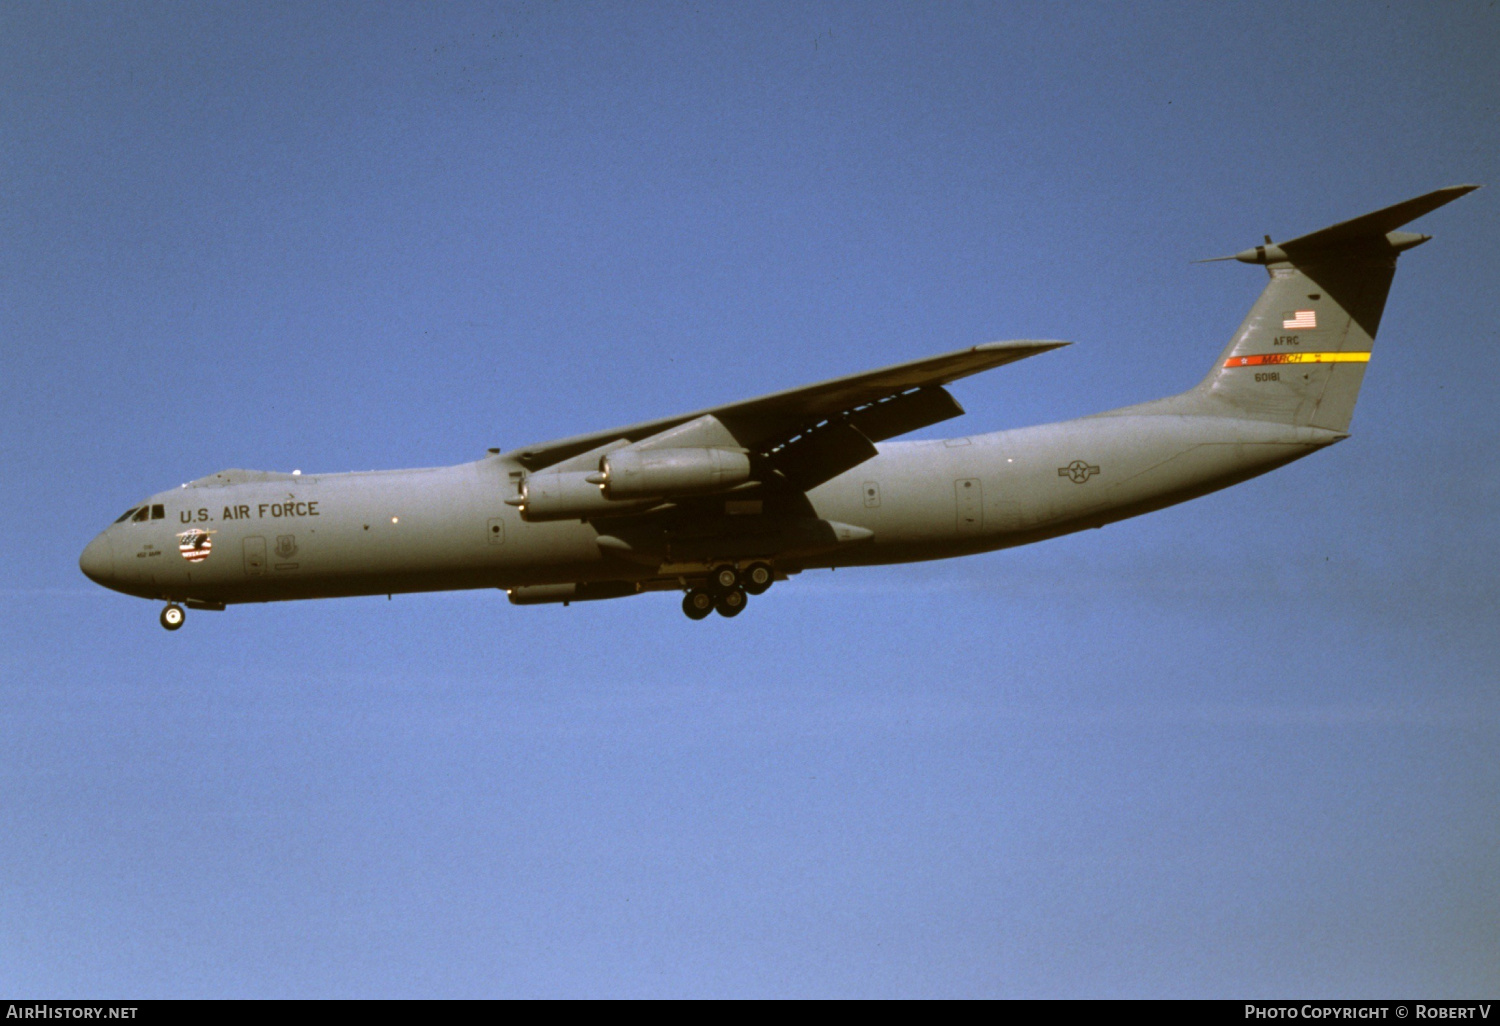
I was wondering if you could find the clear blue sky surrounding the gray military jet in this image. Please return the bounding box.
[0,3,1500,998]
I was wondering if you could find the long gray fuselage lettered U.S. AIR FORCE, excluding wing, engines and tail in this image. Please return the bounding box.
[83,407,1343,603]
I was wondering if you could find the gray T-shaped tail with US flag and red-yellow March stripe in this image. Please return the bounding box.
[1161,185,1479,434]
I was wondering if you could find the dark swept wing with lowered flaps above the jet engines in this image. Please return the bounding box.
[509,341,1068,488]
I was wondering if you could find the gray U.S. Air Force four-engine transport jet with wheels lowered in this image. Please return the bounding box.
[78,186,1478,630]
